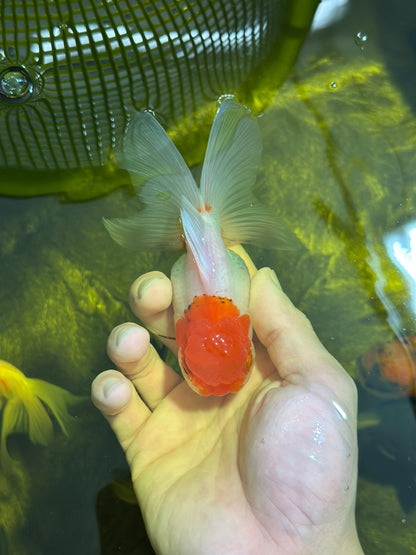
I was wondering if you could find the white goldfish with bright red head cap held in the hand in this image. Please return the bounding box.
[104,98,290,395]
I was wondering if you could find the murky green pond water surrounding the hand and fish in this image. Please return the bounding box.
[0,0,416,555]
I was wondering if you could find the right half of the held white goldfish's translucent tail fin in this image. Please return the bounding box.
[201,98,293,248]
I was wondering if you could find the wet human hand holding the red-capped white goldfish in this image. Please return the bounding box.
[92,254,362,555]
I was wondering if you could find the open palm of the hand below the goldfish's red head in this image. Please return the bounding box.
[122,347,354,553]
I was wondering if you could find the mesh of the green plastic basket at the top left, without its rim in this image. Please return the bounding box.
[0,0,282,169]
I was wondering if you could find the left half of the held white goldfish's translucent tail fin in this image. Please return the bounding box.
[104,112,201,250]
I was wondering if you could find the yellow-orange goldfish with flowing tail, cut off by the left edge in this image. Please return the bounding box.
[0,360,81,467]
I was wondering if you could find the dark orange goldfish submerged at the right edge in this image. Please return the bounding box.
[358,336,416,397]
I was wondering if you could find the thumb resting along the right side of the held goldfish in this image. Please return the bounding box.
[250,268,355,398]
